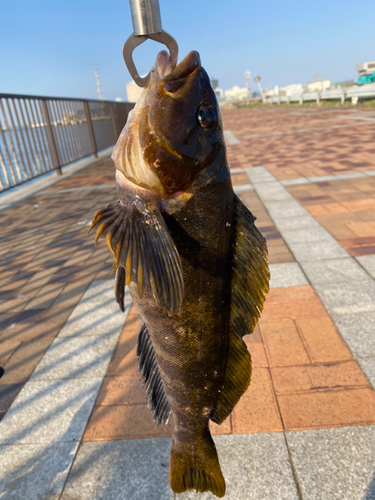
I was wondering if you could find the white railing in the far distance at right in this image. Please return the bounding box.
[266,84,375,104]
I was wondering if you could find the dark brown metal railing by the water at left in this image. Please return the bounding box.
[0,94,134,192]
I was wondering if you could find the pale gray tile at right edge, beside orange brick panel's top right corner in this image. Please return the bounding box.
[315,280,375,314]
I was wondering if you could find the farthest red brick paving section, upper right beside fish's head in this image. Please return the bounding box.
[223,106,375,180]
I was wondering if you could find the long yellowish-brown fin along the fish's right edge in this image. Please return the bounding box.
[211,196,270,424]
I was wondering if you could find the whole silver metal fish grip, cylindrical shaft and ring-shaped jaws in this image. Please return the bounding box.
[122,0,178,87]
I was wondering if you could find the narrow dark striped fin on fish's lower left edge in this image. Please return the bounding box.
[137,323,171,426]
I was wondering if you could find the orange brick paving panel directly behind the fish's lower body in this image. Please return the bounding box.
[84,286,375,441]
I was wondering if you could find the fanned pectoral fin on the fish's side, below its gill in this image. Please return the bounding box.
[89,203,184,314]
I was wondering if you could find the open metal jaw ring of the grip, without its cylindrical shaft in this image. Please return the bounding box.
[122,31,178,87]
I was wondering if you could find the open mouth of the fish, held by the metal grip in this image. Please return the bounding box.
[156,50,201,91]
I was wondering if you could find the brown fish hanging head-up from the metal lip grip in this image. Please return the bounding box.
[90,51,270,498]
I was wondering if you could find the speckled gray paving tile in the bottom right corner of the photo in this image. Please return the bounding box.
[288,426,375,500]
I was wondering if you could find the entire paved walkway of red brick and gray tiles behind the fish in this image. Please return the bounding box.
[0,107,375,500]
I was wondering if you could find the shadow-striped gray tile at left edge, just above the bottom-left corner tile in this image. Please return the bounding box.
[0,378,102,444]
